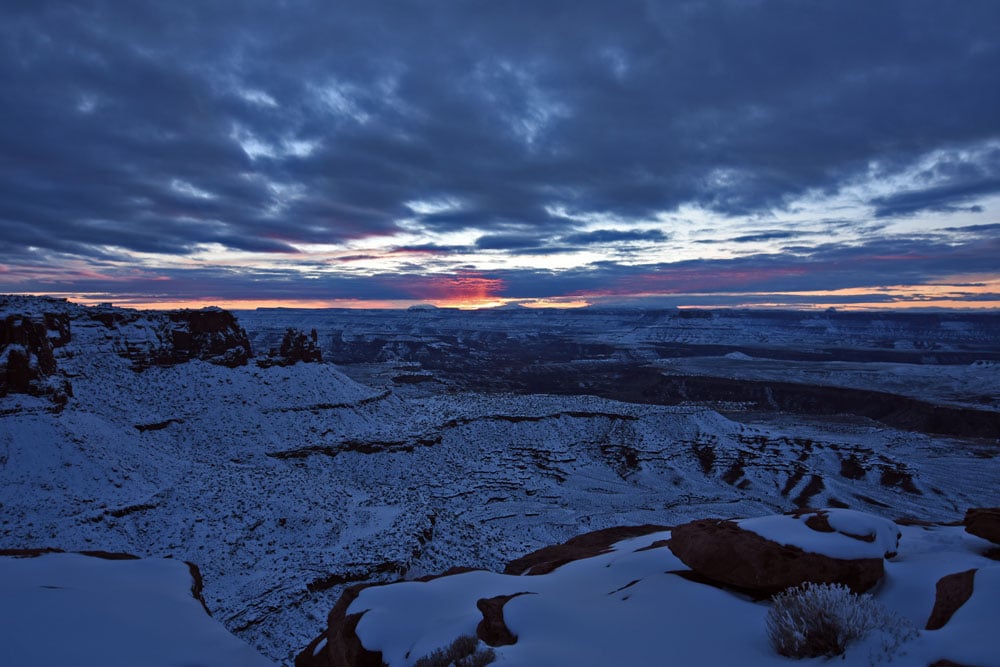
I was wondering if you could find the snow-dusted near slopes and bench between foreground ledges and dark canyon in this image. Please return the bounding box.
[0,298,1000,664]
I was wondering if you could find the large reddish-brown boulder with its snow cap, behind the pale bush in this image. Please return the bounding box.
[668,510,899,597]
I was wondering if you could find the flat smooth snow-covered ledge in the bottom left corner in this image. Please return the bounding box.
[0,553,273,667]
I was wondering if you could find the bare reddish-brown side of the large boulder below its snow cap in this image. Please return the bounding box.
[668,519,884,597]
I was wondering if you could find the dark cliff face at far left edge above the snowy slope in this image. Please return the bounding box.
[0,313,73,405]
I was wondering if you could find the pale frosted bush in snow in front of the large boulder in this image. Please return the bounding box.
[767,583,915,658]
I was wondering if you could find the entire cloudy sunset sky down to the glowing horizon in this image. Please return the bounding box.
[0,0,1000,308]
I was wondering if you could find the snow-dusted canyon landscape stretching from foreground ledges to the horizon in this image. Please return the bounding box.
[0,297,1000,664]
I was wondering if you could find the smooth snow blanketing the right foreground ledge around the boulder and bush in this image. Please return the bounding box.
[299,512,1000,667]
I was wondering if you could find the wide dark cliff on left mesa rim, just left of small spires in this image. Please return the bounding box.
[127,308,253,370]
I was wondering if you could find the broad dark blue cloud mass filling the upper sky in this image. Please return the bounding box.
[0,0,1000,284]
